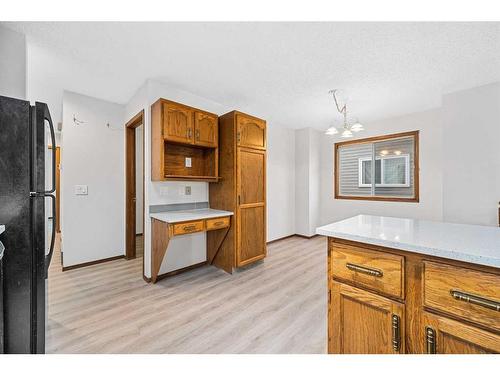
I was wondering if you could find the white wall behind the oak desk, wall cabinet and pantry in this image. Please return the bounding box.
[125,80,295,277]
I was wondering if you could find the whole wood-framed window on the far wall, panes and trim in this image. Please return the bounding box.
[334,131,419,202]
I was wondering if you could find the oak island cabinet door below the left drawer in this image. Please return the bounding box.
[328,280,405,354]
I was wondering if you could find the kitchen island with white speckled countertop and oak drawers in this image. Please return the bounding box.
[317,215,500,353]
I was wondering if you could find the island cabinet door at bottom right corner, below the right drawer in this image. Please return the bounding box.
[422,313,500,354]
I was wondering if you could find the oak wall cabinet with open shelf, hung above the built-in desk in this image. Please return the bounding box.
[151,99,219,181]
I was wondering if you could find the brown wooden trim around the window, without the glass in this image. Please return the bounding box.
[333,130,420,203]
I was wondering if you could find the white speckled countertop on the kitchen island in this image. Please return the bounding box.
[316,215,500,268]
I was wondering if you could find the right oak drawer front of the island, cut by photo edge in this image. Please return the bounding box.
[423,261,500,331]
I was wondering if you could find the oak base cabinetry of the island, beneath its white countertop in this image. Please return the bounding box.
[328,237,500,354]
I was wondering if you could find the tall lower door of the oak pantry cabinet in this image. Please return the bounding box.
[236,147,267,267]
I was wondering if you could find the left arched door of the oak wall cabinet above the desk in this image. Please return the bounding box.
[163,103,194,144]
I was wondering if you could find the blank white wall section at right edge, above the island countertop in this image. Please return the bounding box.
[443,82,500,225]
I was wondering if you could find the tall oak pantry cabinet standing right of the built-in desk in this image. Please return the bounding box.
[207,111,267,273]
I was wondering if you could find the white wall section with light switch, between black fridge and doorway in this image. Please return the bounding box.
[61,92,125,267]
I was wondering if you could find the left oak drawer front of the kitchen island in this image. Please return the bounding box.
[330,243,404,299]
